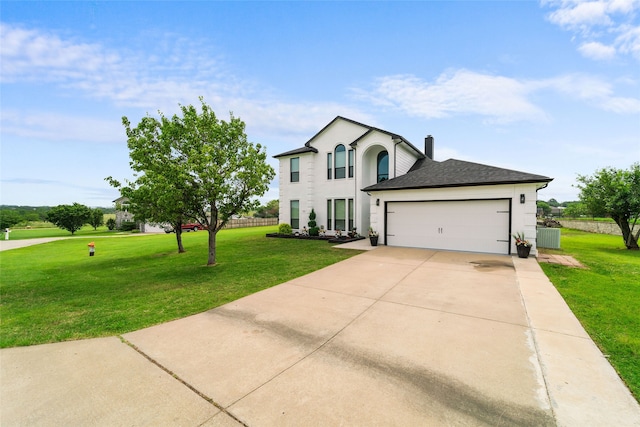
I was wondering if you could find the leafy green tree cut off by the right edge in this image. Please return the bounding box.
[577,163,640,249]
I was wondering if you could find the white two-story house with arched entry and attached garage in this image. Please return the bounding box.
[274,116,552,254]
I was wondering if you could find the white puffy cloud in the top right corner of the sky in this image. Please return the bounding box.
[542,0,640,60]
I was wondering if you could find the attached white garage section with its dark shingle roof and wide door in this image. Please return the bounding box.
[362,158,551,255]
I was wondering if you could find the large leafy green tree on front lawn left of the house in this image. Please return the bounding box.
[122,98,275,265]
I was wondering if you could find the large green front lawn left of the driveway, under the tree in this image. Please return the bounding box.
[0,227,359,348]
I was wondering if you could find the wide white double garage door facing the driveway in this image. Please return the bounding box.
[386,200,510,254]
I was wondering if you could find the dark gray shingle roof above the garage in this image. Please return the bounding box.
[362,158,553,191]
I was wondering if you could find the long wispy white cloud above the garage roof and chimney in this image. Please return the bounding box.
[355,70,640,123]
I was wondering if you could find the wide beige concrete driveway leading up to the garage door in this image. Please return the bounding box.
[0,247,640,427]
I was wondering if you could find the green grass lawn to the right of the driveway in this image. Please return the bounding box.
[541,229,640,401]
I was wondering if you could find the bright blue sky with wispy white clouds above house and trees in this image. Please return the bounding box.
[0,0,640,206]
